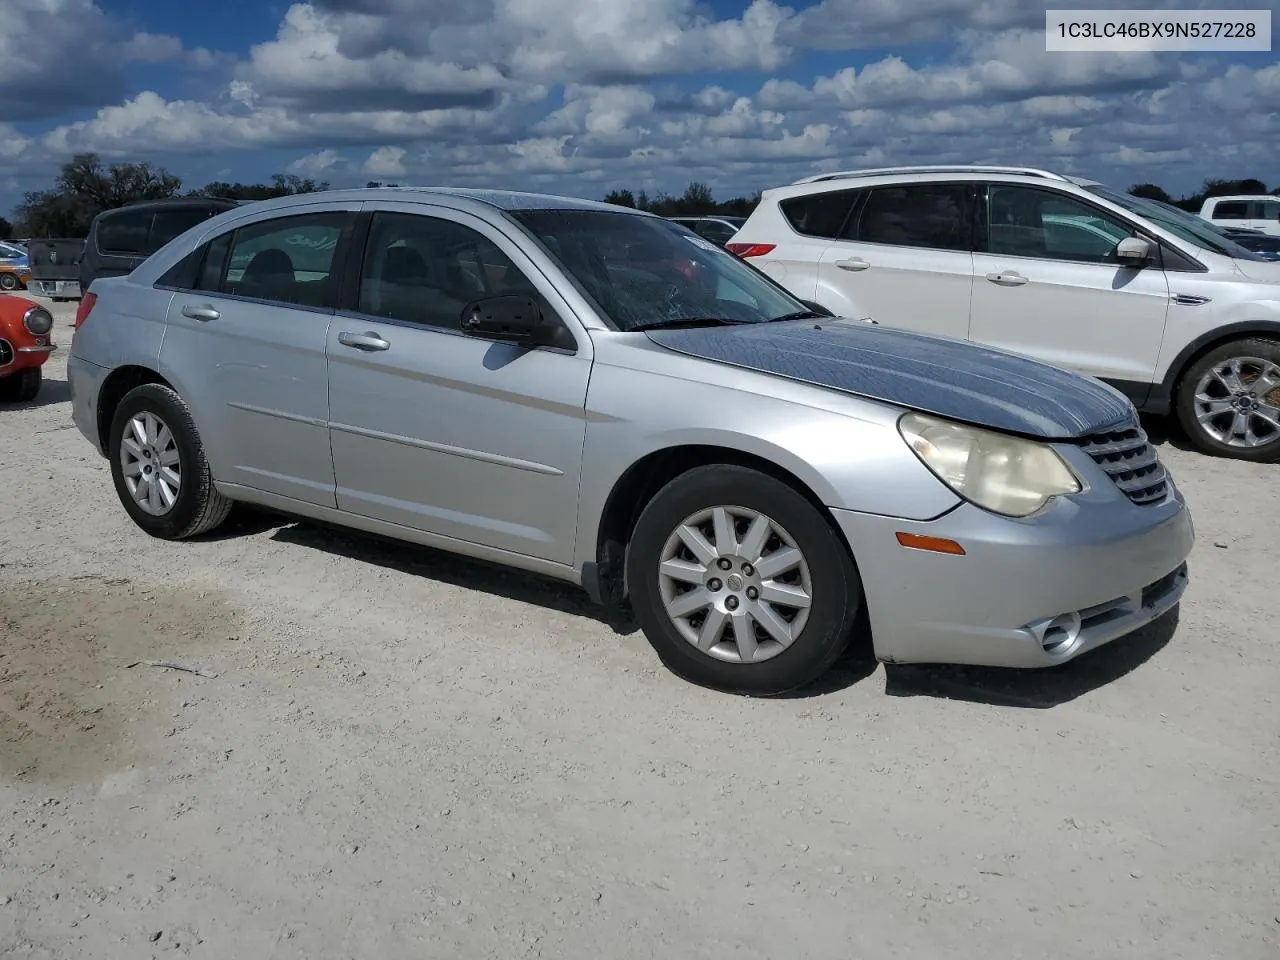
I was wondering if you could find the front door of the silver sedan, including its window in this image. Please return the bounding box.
[328,204,591,563]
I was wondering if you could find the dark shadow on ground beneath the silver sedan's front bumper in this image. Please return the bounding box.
[884,607,1179,710]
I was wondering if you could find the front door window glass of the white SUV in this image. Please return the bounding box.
[987,184,1132,264]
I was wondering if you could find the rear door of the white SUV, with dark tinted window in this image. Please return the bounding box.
[817,182,977,339]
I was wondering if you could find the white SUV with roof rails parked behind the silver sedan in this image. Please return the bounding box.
[727,166,1280,462]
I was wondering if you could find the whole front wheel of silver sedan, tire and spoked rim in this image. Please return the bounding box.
[627,465,861,696]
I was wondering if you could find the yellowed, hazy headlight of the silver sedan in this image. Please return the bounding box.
[897,413,1082,517]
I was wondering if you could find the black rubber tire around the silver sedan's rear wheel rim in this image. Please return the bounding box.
[108,384,232,540]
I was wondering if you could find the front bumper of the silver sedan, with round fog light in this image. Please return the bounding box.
[833,486,1194,667]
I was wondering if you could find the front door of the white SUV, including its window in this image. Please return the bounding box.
[969,183,1169,389]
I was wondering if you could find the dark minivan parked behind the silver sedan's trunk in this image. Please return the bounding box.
[79,197,243,293]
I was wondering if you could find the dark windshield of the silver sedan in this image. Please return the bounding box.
[511,210,809,330]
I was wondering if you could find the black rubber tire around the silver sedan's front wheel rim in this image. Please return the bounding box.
[627,465,863,696]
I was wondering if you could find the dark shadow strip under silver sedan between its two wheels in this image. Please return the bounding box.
[202,504,639,635]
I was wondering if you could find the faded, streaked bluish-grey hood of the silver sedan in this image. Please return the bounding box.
[648,317,1134,440]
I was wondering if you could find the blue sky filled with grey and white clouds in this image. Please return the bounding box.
[0,0,1280,214]
